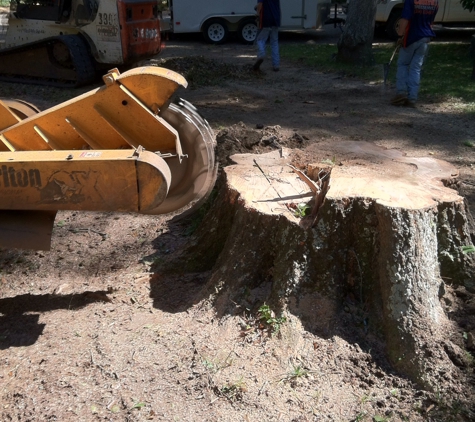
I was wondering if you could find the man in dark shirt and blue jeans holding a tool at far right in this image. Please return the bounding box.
[391,0,439,107]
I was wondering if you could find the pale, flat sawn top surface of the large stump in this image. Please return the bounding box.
[226,142,463,214]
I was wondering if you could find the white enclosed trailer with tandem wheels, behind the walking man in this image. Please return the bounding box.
[163,0,331,44]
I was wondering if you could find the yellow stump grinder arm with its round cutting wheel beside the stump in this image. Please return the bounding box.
[0,66,217,250]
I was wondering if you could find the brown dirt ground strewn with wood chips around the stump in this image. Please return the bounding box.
[0,33,475,422]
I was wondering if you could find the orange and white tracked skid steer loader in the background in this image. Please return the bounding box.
[0,0,161,87]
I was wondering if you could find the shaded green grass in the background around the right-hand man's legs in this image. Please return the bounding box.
[280,42,475,105]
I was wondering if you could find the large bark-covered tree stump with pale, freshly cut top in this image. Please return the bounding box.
[178,142,474,389]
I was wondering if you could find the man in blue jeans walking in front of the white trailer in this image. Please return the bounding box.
[253,0,280,72]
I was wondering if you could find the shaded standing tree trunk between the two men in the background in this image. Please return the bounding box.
[337,0,377,65]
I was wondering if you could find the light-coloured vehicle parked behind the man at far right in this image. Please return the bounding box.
[375,0,475,39]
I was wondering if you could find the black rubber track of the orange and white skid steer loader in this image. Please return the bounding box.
[0,35,96,88]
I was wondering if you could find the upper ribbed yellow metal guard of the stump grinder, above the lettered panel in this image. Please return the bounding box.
[0,66,187,156]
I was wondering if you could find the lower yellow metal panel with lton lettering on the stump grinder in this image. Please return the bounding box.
[0,150,171,214]
